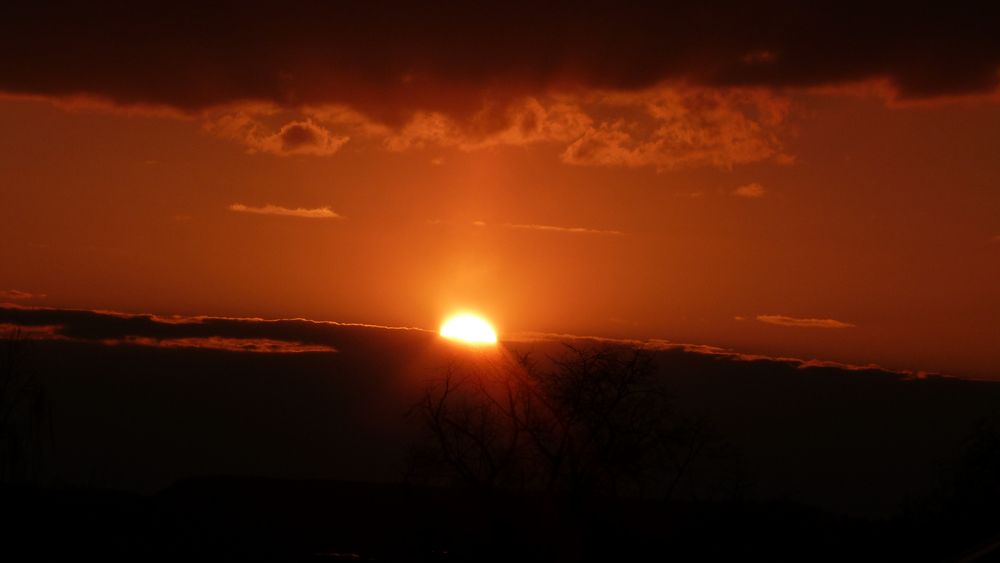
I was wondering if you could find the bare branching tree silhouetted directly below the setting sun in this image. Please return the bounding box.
[412,346,733,499]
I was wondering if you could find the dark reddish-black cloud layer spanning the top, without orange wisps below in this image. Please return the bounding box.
[0,0,1000,119]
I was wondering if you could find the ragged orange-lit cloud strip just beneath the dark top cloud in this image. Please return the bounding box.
[290,84,792,169]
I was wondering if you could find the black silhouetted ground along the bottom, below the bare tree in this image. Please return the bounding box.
[2,477,1000,561]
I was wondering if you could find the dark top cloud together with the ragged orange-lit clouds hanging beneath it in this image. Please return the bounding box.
[0,4,1000,170]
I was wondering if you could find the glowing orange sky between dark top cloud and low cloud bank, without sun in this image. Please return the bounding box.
[0,3,1000,377]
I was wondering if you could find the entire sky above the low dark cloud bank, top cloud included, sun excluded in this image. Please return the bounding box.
[0,1,1000,377]
